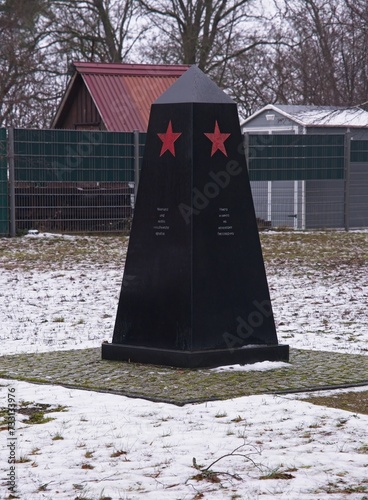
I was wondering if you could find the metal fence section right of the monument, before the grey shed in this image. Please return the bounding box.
[246,134,368,230]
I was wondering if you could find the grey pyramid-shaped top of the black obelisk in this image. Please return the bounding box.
[154,65,234,104]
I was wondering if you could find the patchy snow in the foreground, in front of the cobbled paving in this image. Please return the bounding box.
[0,381,368,500]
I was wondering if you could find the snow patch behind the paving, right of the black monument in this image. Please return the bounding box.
[268,262,368,354]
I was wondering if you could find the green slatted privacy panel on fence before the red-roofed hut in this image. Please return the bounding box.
[14,129,138,183]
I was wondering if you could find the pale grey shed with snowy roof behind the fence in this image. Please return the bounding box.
[241,104,368,229]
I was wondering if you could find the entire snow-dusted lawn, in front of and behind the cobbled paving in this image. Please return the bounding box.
[0,232,368,500]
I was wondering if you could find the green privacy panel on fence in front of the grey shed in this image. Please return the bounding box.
[248,135,344,181]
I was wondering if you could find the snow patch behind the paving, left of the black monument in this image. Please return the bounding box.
[0,269,121,354]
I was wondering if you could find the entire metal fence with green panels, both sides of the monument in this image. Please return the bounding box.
[0,129,368,235]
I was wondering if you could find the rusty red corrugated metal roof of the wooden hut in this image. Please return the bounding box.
[66,62,189,132]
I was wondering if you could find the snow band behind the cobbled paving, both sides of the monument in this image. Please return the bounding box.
[0,233,368,354]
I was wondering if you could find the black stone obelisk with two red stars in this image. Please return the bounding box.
[102,66,289,368]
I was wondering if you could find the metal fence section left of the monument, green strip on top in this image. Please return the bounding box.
[8,129,145,234]
